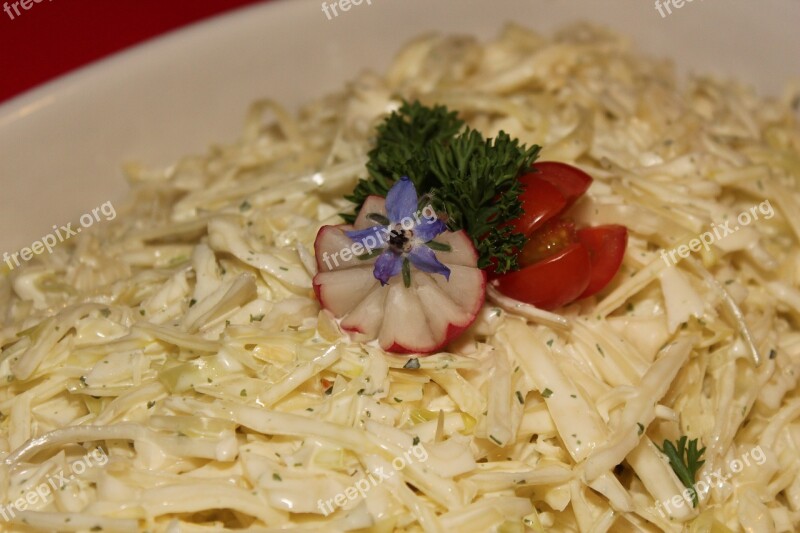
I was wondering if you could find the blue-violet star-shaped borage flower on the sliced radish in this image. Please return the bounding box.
[345,176,450,286]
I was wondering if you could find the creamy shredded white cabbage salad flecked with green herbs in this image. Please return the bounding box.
[0,21,800,533]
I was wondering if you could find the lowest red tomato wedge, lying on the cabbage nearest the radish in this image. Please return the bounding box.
[496,243,592,310]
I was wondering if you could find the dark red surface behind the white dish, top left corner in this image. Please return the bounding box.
[0,0,267,102]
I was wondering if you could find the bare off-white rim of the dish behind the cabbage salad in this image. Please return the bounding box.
[0,0,800,254]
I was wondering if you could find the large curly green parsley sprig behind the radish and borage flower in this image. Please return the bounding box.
[344,102,540,273]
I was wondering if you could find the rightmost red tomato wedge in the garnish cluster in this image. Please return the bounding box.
[578,225,628,298]
